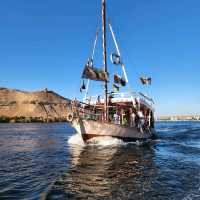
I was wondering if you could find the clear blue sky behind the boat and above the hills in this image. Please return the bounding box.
[0,0,200,115]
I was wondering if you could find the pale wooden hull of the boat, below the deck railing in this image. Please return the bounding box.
[72,119,155,141]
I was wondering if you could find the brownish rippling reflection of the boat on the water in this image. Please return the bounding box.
[47,142,156,199]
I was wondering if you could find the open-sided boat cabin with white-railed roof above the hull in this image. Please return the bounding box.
[72,93,154,128]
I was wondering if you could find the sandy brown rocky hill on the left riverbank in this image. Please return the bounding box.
[0,88,70,121]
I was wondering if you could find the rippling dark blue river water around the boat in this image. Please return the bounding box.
[0,122,200,200]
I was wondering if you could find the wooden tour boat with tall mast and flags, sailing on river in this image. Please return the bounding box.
[67,0,155,142]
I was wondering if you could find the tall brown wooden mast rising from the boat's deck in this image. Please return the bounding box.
[102,0,109,121]
